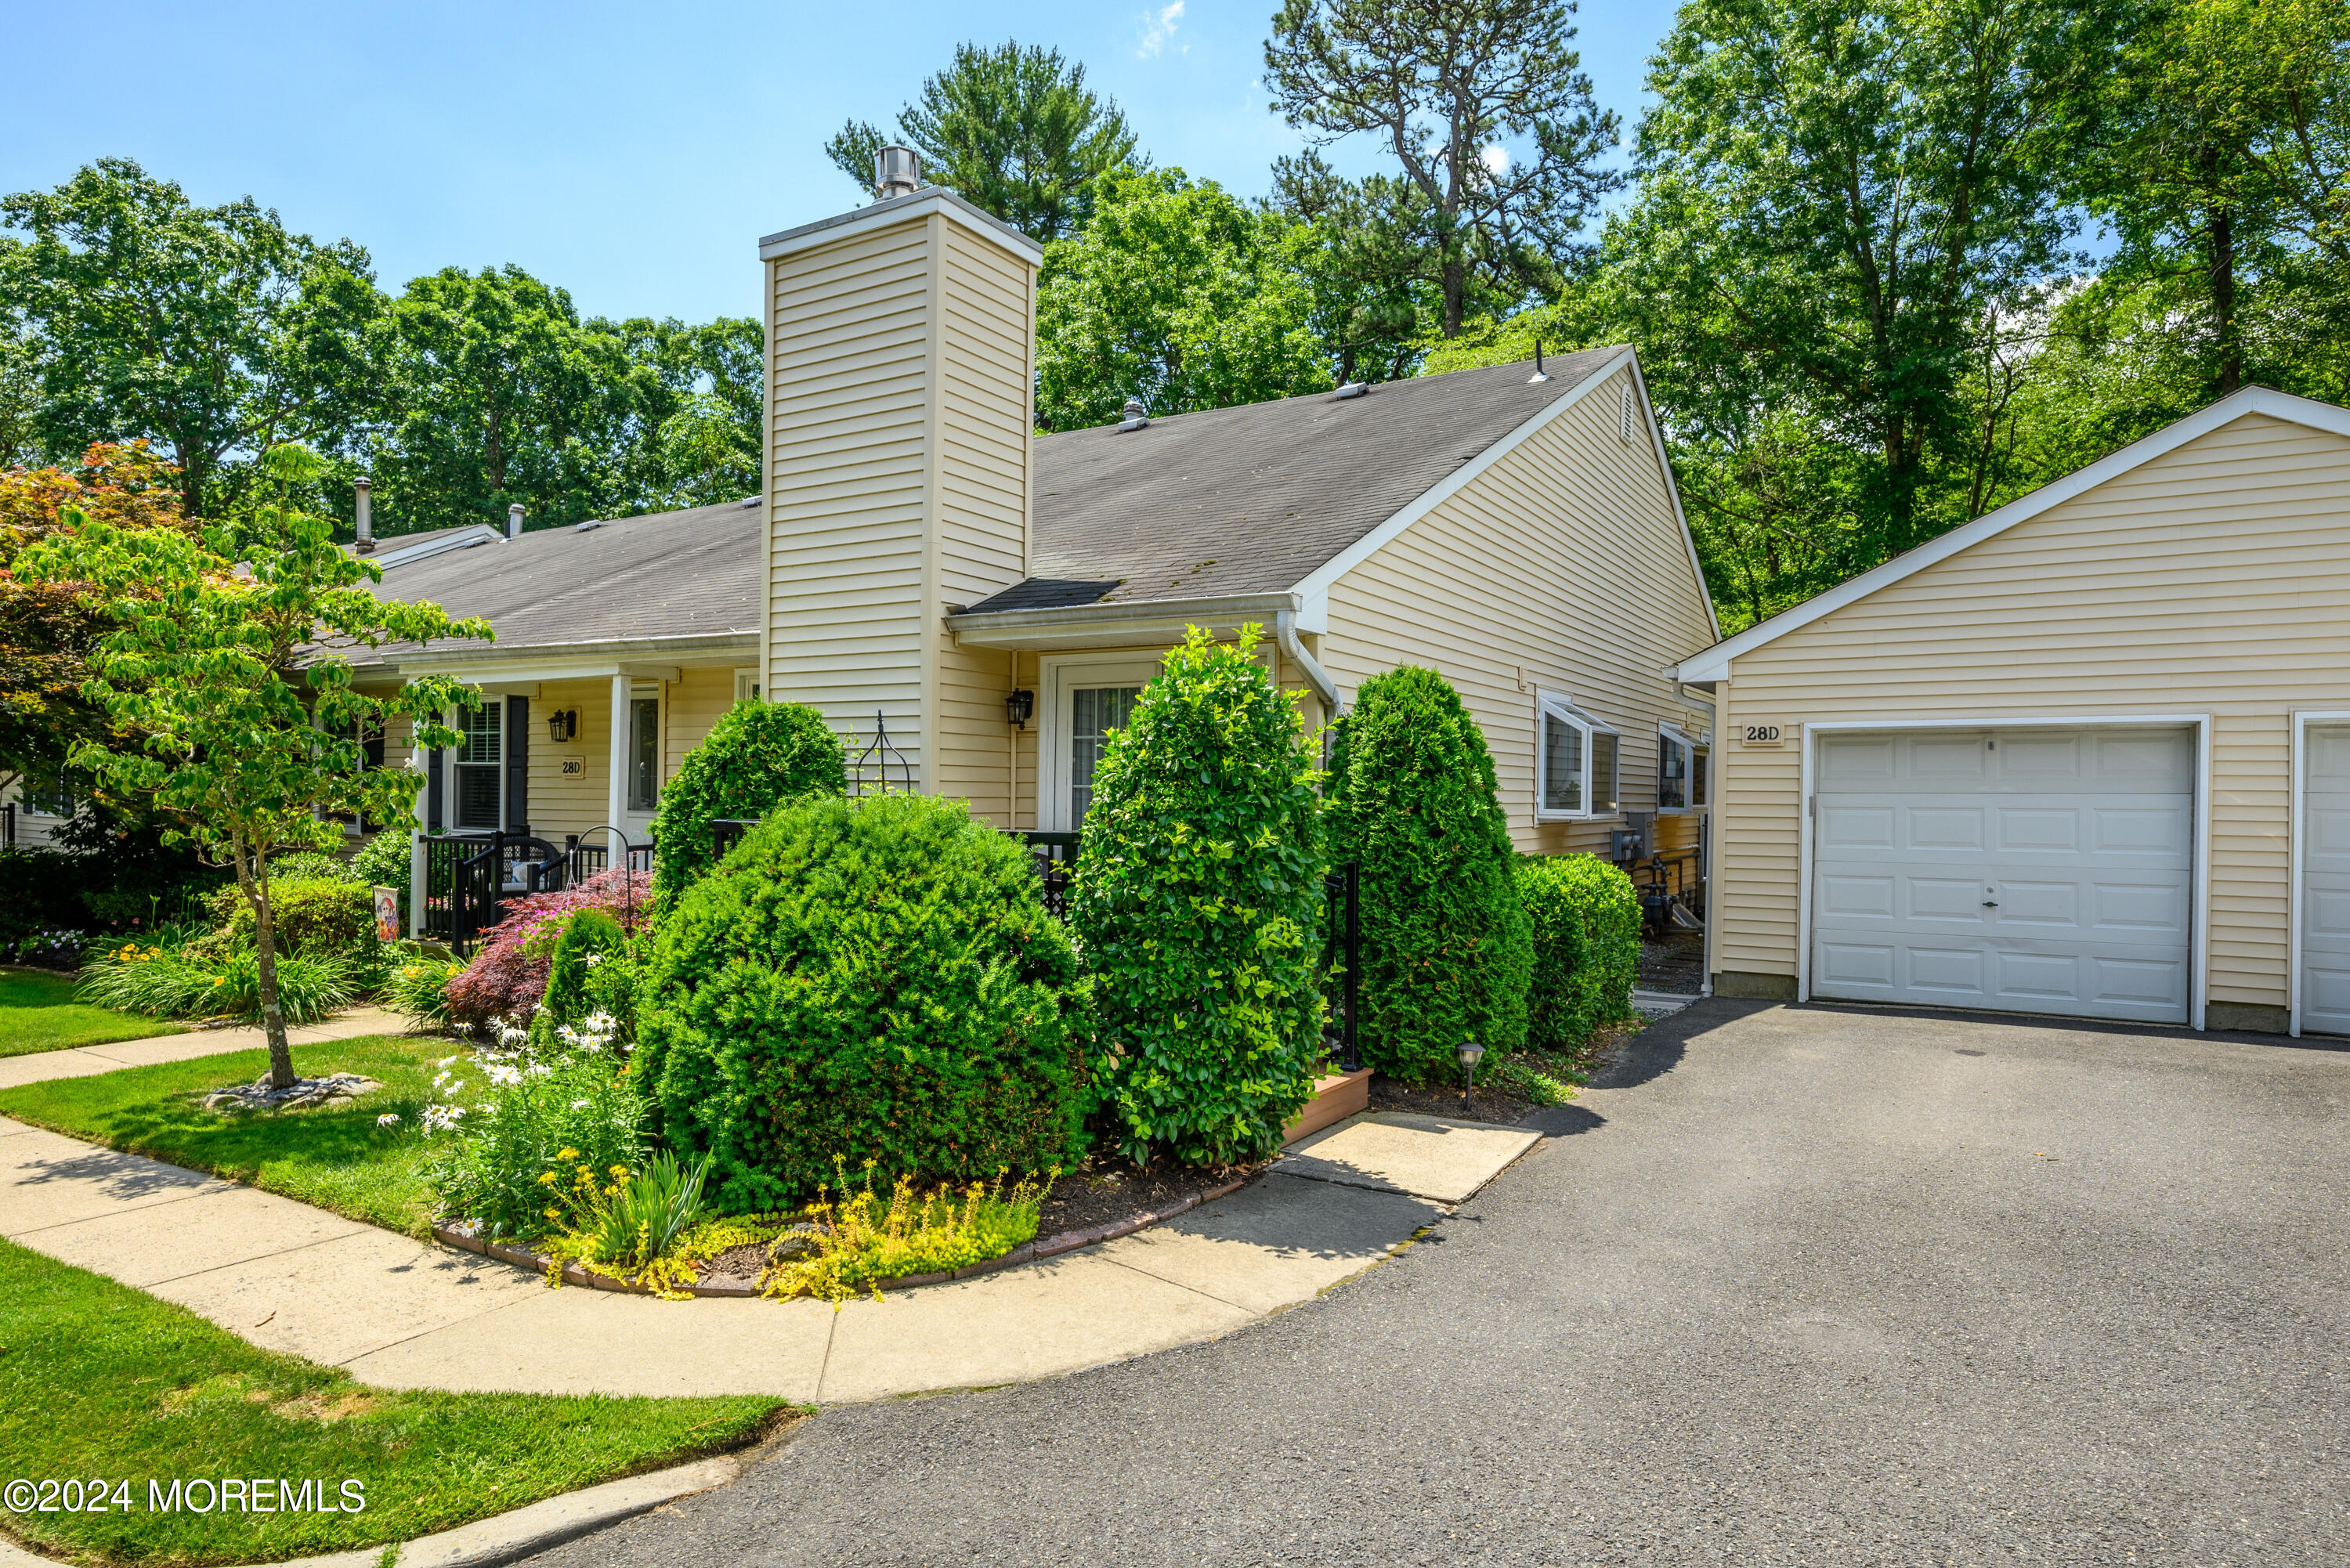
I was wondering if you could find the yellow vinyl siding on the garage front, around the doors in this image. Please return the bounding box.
[1720,414,2350,1006]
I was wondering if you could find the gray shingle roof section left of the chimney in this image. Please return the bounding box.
[352,500,766,665]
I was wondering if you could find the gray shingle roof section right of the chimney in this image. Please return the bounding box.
[971,348,1622,613]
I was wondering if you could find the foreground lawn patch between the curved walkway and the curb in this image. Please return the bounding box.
[0,1241,790,1566]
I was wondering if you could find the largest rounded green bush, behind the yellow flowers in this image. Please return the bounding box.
[632,795,1090,1213]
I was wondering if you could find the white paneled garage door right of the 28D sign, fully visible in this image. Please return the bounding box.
[1812,724,2190,1023]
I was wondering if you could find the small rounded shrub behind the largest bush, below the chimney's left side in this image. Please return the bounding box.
[653,703,848,903]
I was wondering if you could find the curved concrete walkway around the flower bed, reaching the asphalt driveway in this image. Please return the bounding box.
[0,1037,1539,1404]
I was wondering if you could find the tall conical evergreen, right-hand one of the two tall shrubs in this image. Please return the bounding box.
[1330,665,1532,1084]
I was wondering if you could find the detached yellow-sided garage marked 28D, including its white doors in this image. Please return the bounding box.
[1673,388,2350,1035]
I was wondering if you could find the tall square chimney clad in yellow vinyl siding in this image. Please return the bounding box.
[764,211,1036,823]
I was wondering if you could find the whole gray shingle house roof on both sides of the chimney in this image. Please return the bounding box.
[355,348,1619,665]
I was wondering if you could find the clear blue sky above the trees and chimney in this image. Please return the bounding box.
[0,0,1671,320]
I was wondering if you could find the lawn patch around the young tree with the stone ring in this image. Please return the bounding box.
[0,1035,463,1241]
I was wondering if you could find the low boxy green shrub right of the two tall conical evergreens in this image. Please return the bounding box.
[1516,856,1640,1051]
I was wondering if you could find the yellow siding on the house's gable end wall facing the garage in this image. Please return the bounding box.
[1321,371,1713,854]
